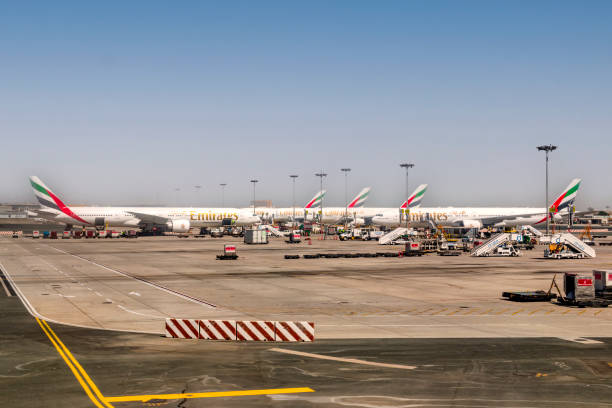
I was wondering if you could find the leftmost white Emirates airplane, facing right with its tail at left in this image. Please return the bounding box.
[30,176,261,233]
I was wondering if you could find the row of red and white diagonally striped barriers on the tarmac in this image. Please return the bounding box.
[166,319,314,341]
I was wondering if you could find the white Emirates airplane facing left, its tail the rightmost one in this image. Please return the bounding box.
[372,179,582,228]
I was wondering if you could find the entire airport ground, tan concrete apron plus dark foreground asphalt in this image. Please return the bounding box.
[0,237,612,408]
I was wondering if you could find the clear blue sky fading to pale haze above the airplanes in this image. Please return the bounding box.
[0,1,612,207]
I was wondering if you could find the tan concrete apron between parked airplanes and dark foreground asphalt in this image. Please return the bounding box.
[0,237,612,339]
